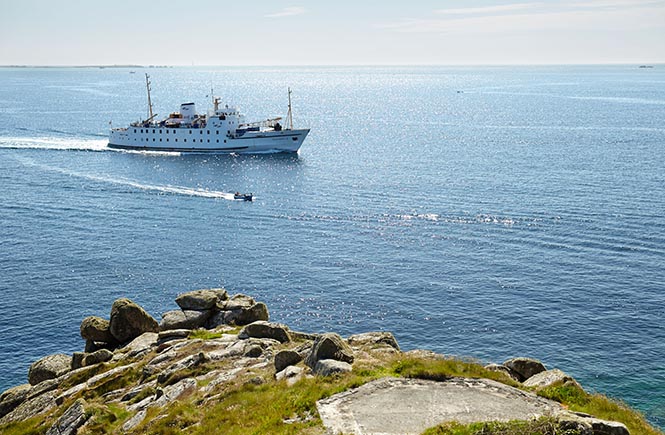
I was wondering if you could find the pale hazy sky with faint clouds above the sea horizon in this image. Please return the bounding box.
[0,0,665,65]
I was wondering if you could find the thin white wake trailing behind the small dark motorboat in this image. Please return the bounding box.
[17,158,235,201]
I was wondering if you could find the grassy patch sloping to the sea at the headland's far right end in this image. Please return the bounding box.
[538,383,662,435]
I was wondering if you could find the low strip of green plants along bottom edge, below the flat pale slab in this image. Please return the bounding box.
[422,417,580,435]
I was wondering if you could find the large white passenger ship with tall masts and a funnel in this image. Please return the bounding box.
[108,74,309,154]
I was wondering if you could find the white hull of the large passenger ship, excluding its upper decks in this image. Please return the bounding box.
[108,127,309,154]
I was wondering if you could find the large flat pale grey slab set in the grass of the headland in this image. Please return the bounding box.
[317,378,562,435]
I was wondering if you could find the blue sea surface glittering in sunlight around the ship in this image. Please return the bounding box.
[0,65,665,427]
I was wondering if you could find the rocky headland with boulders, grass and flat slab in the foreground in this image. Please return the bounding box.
[0,289,661,435]
